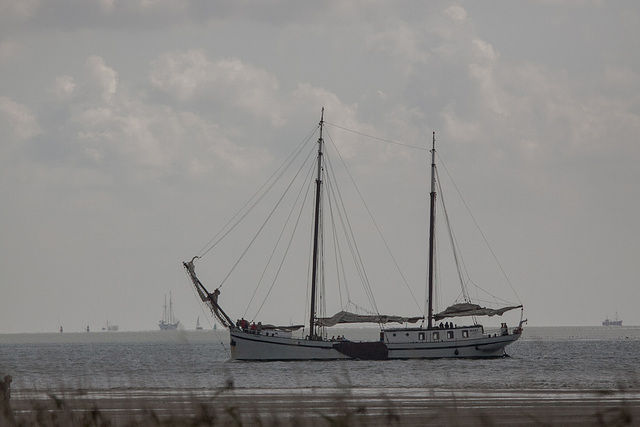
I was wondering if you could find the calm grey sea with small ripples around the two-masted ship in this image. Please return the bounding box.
[0,327,640,398]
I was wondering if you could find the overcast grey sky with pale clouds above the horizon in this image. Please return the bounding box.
[0,0,640,333]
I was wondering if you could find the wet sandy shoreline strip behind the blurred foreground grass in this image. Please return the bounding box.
[6,389,640,426]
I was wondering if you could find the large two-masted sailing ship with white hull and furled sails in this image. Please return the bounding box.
[183,108,526,361]
